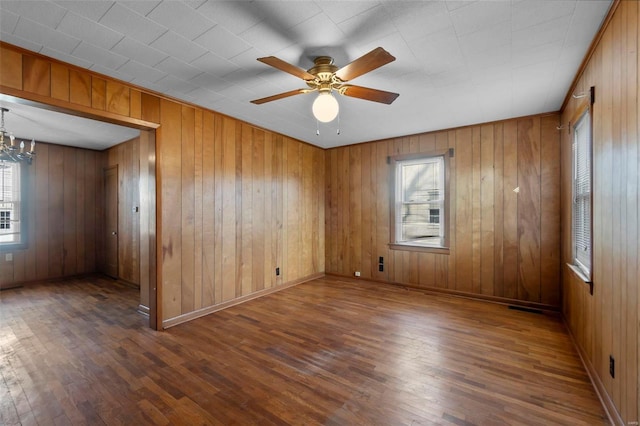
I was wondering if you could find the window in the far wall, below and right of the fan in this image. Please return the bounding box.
[391,153,448,251]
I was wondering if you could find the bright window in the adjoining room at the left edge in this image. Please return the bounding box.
[0,161,26,249]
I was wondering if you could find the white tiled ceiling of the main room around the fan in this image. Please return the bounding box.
[0,0,611,147]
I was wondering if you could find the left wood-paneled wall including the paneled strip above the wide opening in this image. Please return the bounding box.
[0,42,325,327]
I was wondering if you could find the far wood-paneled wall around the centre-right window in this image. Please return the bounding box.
[325,114,560,308]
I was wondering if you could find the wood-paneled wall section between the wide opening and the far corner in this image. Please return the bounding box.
[158,106,324,325]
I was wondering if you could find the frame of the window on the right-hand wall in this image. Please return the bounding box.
[569,102,593,282]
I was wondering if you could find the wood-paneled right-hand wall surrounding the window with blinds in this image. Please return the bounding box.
[562,1,640,424]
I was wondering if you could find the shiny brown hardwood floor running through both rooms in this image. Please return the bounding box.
[0,277,608,425]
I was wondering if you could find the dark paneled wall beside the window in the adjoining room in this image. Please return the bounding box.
[0,142,102,287]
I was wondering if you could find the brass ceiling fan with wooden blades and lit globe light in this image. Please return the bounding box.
[251,47,399,123]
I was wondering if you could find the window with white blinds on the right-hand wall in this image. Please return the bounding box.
[571,108,591,282]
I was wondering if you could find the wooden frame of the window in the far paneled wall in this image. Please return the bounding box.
[389,149,452,254]
